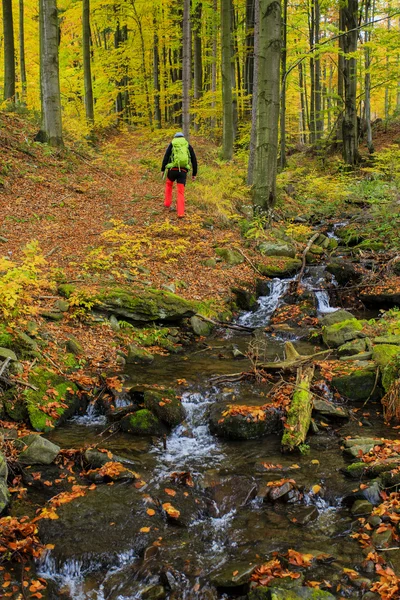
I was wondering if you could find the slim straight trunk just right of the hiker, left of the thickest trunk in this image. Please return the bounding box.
[221,0,234,160]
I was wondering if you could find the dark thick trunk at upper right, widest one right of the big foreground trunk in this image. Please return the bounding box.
[340,0,360,166]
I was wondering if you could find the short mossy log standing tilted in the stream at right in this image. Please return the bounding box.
[281,366,314,452]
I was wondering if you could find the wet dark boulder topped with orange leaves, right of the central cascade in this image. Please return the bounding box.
[210,403,281,440]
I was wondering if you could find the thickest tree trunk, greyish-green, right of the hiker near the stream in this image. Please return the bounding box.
[253,0,281,211]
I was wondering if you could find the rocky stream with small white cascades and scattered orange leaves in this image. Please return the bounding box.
[32,267,385,600]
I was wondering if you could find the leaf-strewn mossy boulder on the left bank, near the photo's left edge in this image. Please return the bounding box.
[24,367,80,431]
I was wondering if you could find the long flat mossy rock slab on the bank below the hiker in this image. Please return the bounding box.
[95,288,196,323]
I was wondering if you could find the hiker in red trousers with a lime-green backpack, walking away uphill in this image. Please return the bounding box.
[161,132,197,218]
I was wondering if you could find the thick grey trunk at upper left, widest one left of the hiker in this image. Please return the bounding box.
[36,0,63,146]
